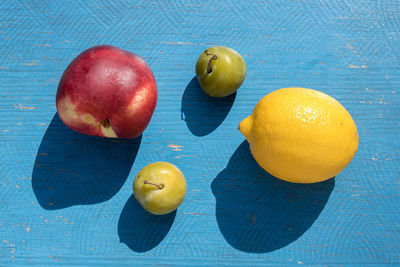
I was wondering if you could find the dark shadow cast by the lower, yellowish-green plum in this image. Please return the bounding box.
[118,195,176,252]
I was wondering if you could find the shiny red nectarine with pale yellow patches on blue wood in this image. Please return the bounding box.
[56,45,157,138]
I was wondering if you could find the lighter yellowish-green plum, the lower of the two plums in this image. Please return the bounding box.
[133,162,186,215]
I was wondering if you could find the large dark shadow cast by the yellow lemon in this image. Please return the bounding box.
[211,141,335,253]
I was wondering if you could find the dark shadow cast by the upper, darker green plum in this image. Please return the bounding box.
[181,77,236,136]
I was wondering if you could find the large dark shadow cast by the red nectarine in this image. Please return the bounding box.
[32,113,142,210]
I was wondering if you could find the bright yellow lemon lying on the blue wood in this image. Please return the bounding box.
[239,87,358,183]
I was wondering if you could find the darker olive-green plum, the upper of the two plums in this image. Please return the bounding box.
[196,46,246,97]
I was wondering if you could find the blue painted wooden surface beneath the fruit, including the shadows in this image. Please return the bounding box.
[0,0,400,266]
